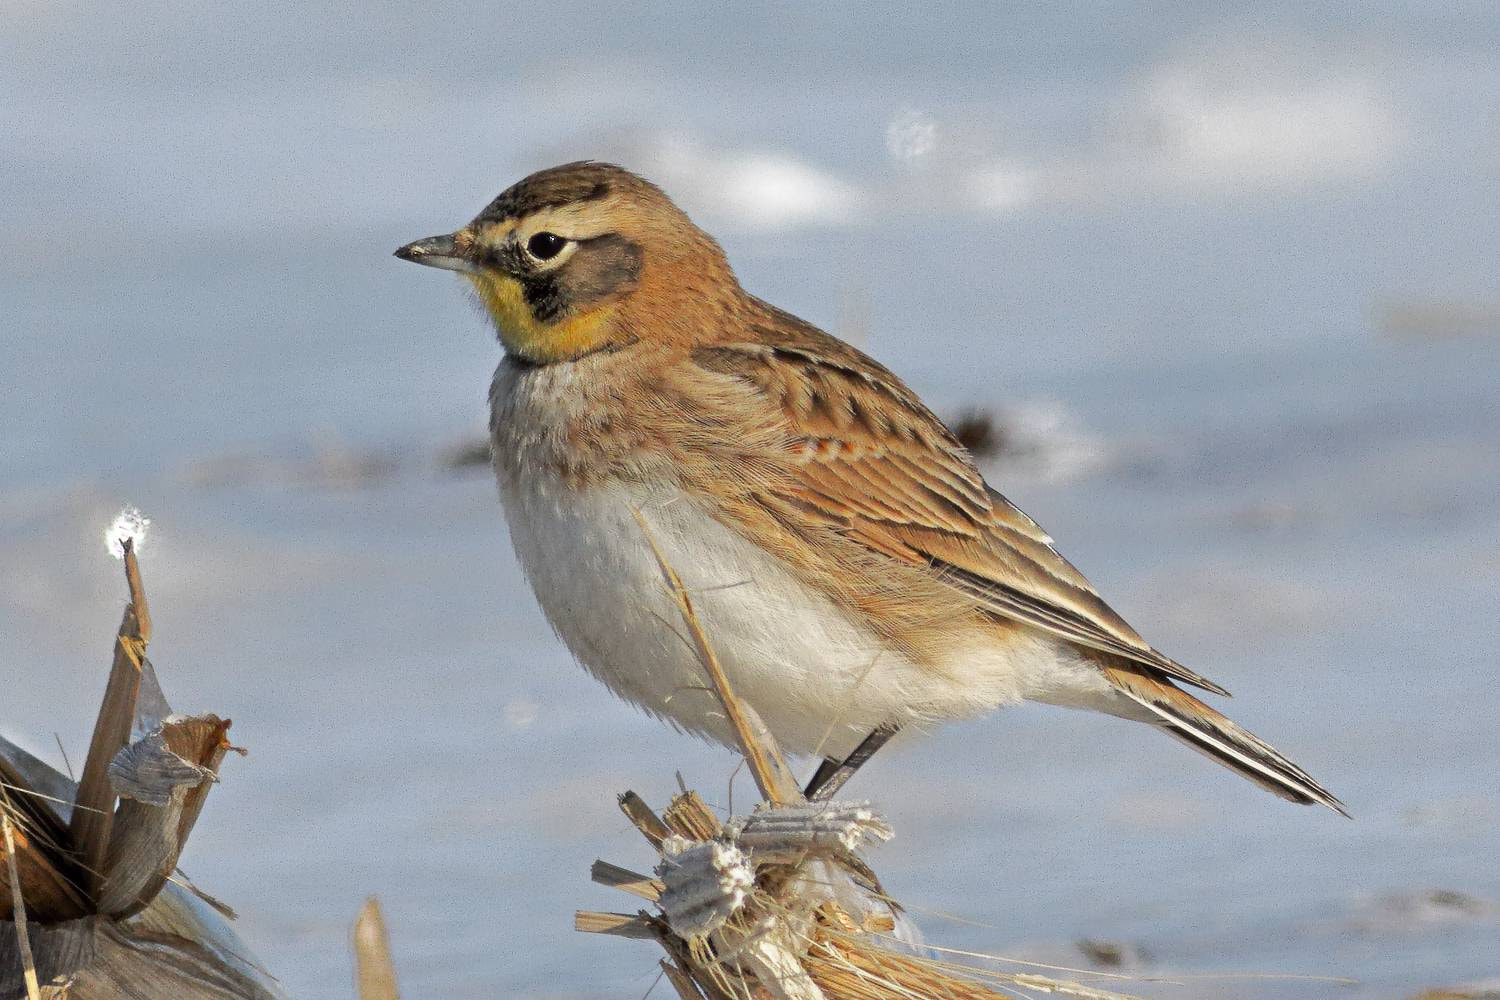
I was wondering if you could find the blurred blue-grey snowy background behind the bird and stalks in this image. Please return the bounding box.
[0,0,1500,1000]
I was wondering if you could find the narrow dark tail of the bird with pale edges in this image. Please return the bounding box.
[1104,663,1349,816]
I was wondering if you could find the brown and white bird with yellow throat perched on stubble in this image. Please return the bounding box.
[396,160,1347,816]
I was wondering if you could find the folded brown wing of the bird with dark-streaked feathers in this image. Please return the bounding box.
[693,307,1227,694]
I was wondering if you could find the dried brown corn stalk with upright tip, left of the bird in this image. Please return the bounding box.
[0,543,282,1000]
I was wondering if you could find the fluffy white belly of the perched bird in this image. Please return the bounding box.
[501,474,1103,756]
